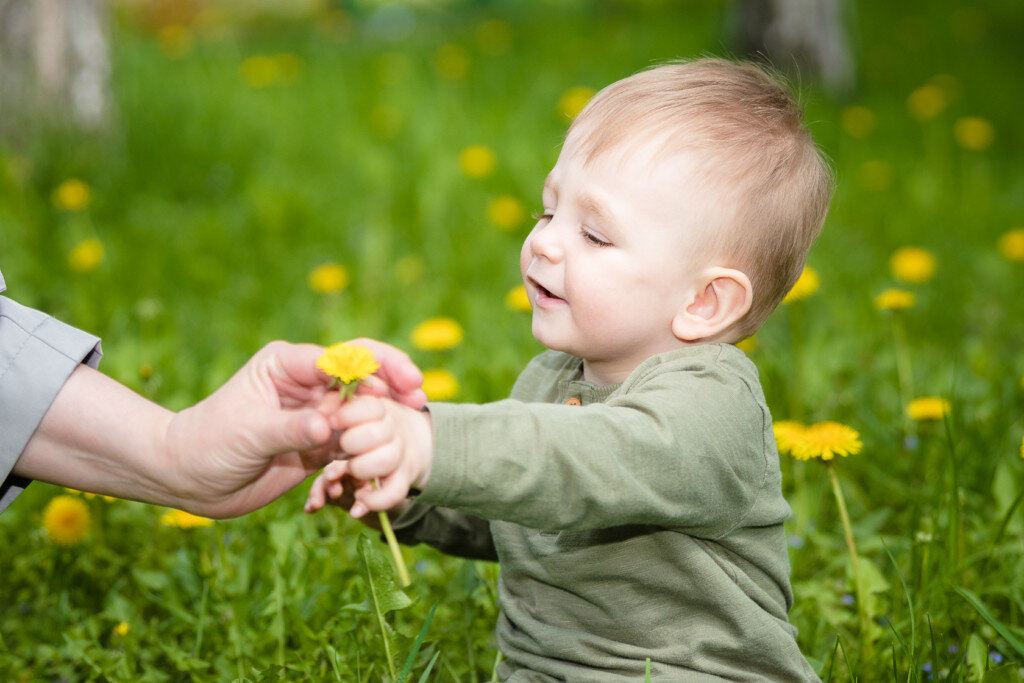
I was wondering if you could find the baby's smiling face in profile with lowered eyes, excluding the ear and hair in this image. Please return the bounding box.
[520,137,710,384]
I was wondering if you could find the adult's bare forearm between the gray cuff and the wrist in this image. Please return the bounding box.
[14,366,176,505]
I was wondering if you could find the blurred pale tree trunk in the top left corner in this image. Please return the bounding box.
[0,0,111,133]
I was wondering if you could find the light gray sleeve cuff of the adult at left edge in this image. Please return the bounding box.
[0,290,101,512]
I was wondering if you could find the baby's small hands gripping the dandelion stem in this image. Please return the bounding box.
[306,396,433,517]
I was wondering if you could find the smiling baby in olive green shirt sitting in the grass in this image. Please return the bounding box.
[307,59,833,681]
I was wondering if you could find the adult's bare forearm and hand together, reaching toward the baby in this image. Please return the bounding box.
[14,340,426,517]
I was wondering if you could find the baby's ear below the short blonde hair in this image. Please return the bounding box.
[672,267,754,344]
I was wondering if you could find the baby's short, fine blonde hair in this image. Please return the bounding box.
[566,58,835,340]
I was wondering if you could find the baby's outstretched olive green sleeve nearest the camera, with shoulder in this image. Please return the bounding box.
[422,345,788,539]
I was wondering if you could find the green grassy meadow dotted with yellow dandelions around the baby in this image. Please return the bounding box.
[0,0,1024,681]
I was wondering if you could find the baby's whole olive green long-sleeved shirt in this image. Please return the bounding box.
[397,343,817,681]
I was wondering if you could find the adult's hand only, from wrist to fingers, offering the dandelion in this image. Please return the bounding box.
[167,339,426,517]
